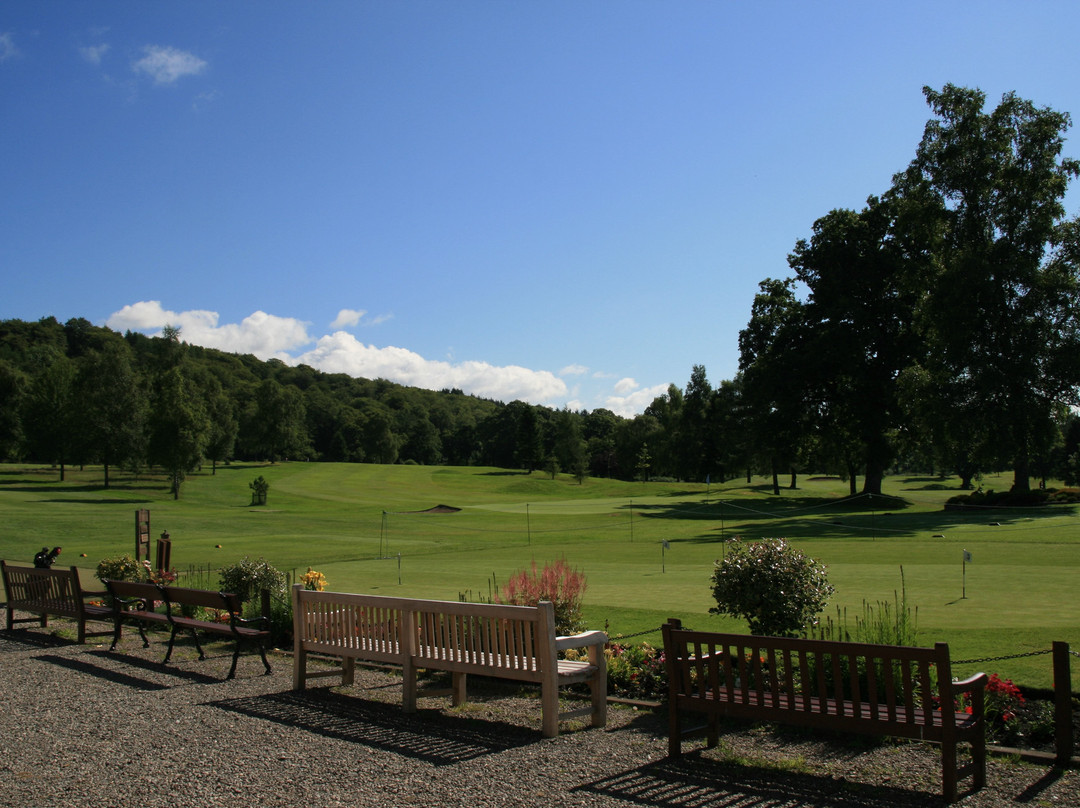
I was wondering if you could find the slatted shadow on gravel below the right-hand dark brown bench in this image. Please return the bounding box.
[571,752,945,808]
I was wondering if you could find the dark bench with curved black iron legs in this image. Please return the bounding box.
[105,580,270,679]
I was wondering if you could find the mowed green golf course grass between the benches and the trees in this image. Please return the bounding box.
[0,463,1080,687]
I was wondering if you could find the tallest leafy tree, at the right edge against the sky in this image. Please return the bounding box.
[897,84,1080,490]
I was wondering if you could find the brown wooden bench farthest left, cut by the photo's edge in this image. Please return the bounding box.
[0,561,112,643]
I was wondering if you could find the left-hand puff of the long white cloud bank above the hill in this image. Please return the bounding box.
[105,300,312,361]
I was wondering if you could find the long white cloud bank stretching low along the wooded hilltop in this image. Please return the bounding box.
[106,300,570,404]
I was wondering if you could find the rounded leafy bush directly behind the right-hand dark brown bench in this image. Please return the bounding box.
[711,539,834,636]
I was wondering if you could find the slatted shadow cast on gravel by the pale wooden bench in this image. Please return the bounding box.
[208,688,538,766]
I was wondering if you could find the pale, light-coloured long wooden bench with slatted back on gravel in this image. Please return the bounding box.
[293,584,607,738]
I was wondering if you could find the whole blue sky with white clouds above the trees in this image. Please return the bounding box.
[0,0,1080,416]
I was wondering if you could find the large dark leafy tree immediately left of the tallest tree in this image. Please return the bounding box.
[788,198,927,494]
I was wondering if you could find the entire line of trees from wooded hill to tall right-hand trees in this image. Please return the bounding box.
[0,85,1080,496]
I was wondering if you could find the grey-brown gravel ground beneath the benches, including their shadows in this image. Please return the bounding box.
[0,617,1080,808]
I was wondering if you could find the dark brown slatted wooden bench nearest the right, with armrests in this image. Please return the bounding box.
[663,620,988,803]
